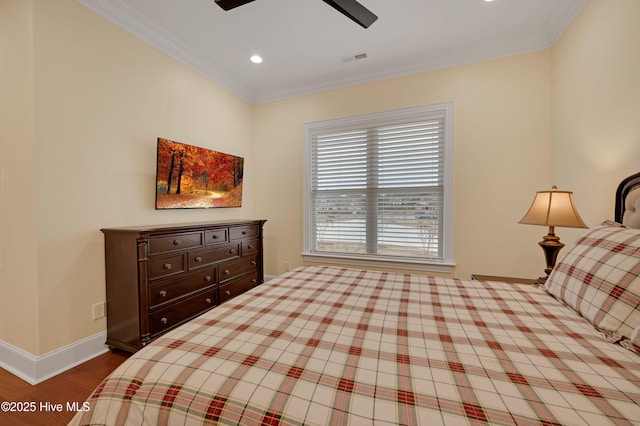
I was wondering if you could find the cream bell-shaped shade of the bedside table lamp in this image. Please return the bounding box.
[518,186,588,228]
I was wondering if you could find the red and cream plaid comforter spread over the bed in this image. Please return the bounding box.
[72,267,640,426]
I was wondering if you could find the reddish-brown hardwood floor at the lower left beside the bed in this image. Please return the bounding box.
[0,351,129,426]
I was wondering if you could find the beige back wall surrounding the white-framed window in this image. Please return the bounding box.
[255,51,551,278]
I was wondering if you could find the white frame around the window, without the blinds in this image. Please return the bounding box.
[302,102,455,273]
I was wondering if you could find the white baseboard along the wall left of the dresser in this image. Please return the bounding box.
[0,331,109,385]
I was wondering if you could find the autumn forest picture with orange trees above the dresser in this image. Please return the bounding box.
[156,138,244,210]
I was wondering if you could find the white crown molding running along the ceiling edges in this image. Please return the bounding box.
[76,0,588,104]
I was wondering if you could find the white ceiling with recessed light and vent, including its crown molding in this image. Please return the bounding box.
[77,0,587,103]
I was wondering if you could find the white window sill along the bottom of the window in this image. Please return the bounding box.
[302,252,456,274]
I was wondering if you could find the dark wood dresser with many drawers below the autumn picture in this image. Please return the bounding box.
[101,220,266,352]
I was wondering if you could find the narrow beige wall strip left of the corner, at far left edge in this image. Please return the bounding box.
[0,0,39,353]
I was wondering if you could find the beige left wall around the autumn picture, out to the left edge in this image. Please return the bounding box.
[0,0,256,355]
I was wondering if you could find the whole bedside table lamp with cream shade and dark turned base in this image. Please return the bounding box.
[518,185,588,284]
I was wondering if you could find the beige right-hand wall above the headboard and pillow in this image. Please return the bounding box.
[551,0,640,243]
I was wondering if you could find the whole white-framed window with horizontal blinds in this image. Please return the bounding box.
[303,103,453,271]
